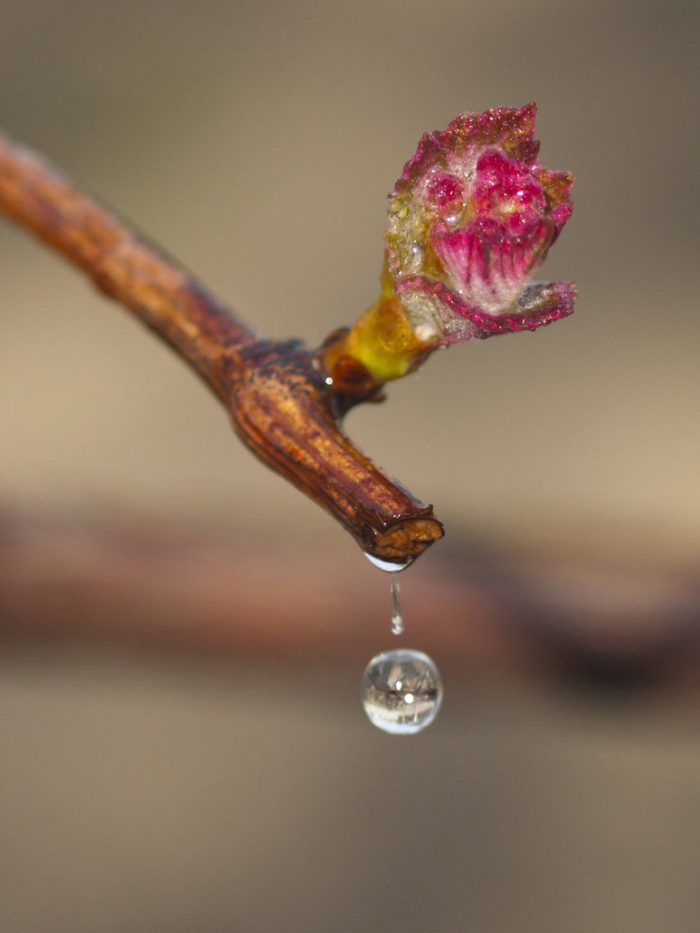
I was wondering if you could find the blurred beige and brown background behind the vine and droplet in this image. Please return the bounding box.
[0,0,700,933]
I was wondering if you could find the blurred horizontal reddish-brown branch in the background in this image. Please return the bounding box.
[0,515,700,695]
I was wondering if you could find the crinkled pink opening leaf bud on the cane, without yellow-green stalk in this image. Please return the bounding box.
[386,104,576,344]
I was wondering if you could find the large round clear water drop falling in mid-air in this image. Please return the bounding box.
[362,648,442,735]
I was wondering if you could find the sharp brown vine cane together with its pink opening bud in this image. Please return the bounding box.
[0,104,574,565]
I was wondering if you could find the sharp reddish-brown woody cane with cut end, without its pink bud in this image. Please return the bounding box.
[0,137,443,564]
